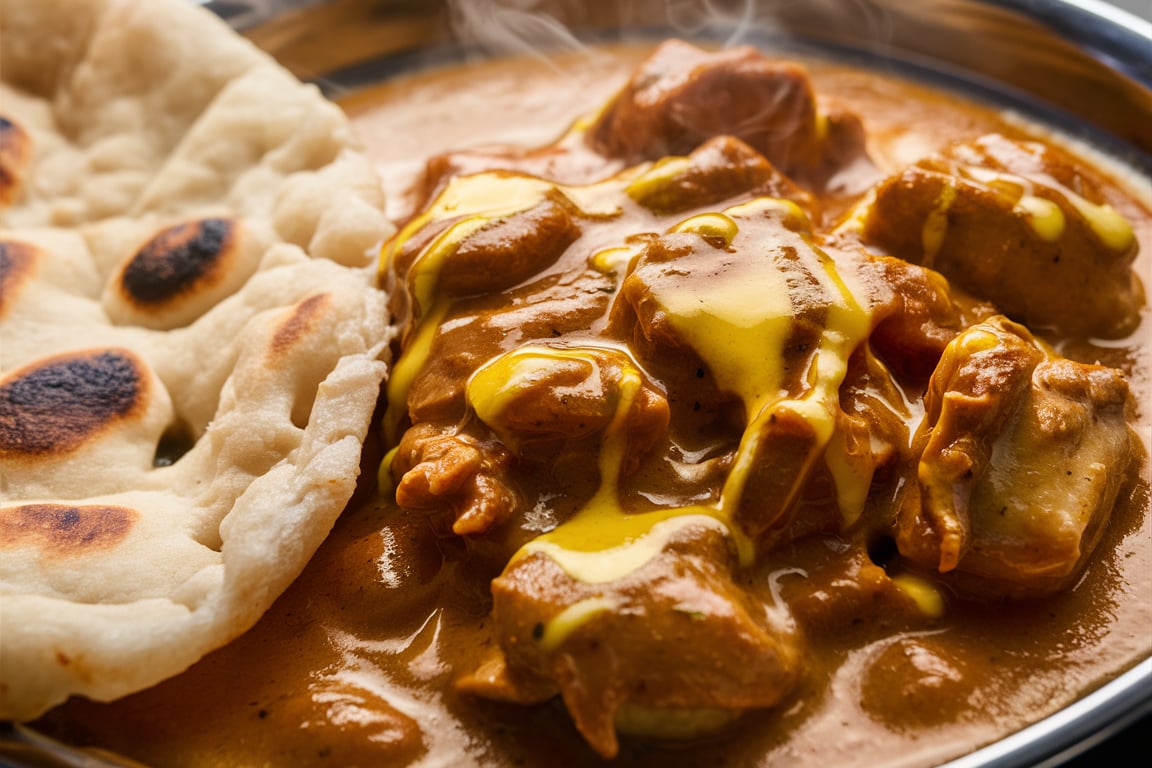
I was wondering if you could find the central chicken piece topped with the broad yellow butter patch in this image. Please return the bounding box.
[613,198,828,400]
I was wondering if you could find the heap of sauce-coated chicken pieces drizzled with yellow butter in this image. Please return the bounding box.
[381,43,1144,758]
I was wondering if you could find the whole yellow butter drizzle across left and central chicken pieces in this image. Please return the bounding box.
[380,168,871,645]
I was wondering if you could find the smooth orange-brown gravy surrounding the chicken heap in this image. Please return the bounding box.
[40,43,1152,768]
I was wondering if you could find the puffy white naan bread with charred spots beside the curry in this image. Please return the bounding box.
[0,0,391,720]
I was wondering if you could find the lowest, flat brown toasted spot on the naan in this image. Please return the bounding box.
[0,503,139,557]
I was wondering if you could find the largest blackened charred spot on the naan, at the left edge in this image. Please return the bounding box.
[0,349,151,457]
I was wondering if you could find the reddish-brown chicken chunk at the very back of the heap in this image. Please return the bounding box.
[586,40,864,183]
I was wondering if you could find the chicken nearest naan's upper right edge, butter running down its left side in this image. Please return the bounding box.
[381,173,608,443]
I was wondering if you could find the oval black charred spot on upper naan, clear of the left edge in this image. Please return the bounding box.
[119,219,240,309]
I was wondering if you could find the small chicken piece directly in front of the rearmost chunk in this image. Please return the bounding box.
[627,136,817,216]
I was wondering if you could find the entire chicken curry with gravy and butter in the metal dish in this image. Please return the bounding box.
[44,41,1152,766]
